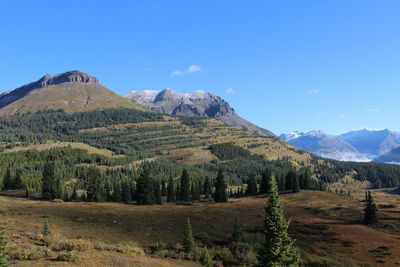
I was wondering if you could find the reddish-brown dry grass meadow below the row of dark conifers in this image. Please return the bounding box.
[1,191,400,266]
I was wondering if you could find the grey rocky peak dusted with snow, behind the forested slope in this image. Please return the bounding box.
[126,89,275,136]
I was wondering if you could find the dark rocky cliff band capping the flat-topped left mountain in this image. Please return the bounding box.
[0,70,99,108]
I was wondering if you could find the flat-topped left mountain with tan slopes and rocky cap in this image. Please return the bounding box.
[0,70,139,115]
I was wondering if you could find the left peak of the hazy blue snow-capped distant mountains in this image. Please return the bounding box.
[280,131,362,161]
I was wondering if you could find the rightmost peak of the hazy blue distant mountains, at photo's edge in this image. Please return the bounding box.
[339,129,400,158]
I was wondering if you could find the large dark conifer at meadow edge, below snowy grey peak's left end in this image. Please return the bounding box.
[136,164,154,205]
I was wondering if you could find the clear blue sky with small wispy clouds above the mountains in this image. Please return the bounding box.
[0,0,400,134]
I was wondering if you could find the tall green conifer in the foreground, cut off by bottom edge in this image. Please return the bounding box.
[258,179,300,267]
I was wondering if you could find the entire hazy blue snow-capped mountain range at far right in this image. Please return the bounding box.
[280,129,400,163]
